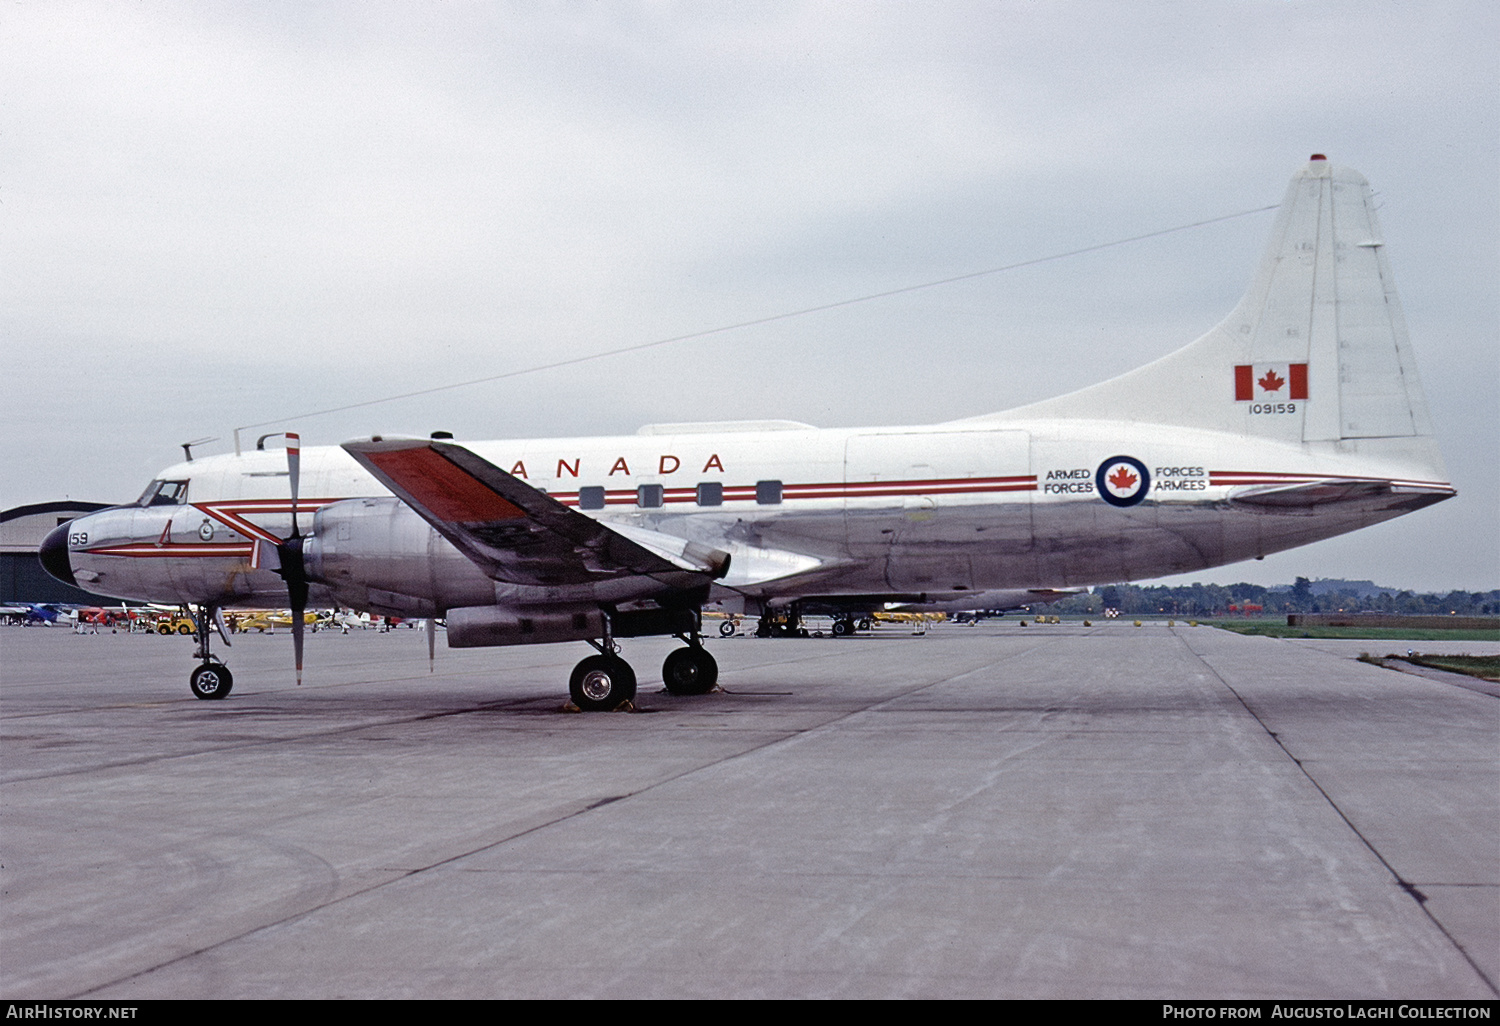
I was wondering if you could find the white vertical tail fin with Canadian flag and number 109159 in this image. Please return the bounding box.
[981,155,1442,477]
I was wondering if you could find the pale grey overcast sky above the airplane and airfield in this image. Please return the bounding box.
[0,0,1500,590]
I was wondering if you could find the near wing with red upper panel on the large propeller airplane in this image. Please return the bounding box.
[344,440,729,588]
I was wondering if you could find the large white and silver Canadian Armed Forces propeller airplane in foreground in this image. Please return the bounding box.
[41,155,1457,710]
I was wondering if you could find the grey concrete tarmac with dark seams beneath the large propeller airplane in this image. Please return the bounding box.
[0,618,1500,999]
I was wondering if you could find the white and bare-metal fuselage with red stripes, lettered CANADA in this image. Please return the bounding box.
[69,420,1452,615]
